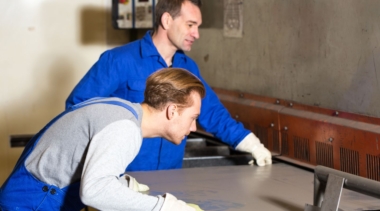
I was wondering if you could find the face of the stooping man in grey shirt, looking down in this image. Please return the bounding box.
[165,91,201,145]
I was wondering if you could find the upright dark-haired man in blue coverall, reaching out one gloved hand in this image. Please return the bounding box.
[66,0,272,171]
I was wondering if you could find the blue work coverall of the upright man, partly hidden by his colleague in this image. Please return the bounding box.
[66,31,250,171]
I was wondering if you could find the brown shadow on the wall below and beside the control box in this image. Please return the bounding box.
[80,7,150,47]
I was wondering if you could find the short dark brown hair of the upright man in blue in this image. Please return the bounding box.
[153,0,202,32]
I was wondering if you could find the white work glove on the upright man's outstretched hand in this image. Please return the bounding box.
[235,133,272,166]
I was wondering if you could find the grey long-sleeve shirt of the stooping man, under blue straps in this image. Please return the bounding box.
[25,98,164,211]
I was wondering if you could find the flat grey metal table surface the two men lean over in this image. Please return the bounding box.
[130,162,380,211]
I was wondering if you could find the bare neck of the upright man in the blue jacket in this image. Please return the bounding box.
[152,30,177,67]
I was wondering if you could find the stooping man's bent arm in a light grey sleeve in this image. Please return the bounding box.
[80,120,164,210]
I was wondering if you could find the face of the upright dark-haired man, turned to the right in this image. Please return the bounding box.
[168,1,202,51]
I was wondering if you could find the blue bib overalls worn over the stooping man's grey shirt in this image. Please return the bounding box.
[0,98,138,211]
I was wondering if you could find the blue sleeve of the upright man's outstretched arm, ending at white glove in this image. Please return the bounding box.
[194,75,251,148]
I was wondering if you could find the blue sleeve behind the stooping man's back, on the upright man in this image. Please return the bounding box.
[66,51,121,109]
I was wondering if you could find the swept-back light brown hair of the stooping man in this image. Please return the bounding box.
[143,68,206,110]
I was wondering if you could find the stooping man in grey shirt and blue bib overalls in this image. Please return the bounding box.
[0,68,205,211]
